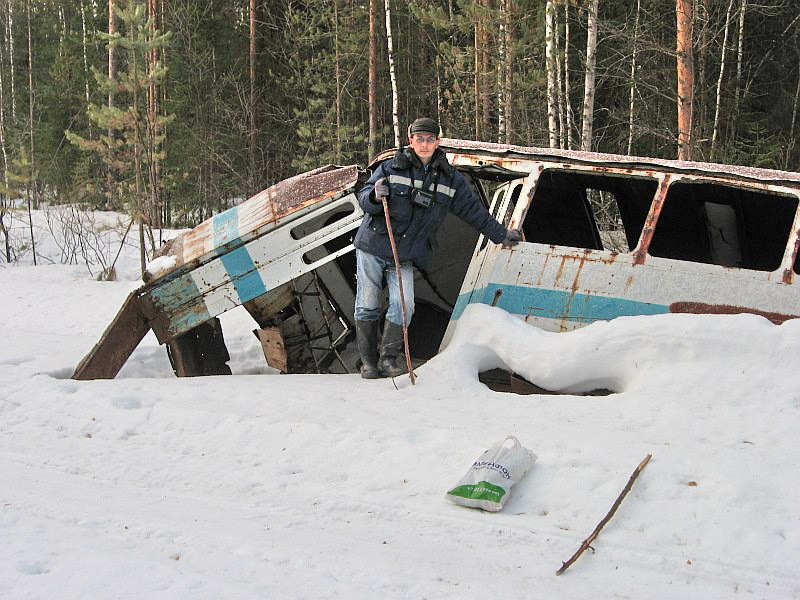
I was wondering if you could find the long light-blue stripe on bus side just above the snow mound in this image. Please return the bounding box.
[450,283,669,324]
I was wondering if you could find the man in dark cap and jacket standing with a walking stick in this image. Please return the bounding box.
[353,118,522,379]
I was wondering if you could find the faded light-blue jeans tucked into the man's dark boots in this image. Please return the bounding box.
[355,248,414,326]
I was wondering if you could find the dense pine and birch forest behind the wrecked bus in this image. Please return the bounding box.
[0,0,800,272]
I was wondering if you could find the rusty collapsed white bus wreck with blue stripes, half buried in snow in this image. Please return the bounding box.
[73,139,800,379]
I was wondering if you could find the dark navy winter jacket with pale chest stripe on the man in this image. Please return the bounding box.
[353,148,507,265]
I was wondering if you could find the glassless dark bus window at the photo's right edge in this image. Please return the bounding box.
[648,181,798,271]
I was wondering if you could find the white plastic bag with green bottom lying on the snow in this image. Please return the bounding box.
[446,435,536,512]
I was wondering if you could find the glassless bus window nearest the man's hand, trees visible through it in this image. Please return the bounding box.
[522,169,658,252]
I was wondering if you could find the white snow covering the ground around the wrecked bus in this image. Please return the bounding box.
[0,212,800,600]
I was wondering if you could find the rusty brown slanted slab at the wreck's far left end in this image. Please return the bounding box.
[72,290,150,381]
